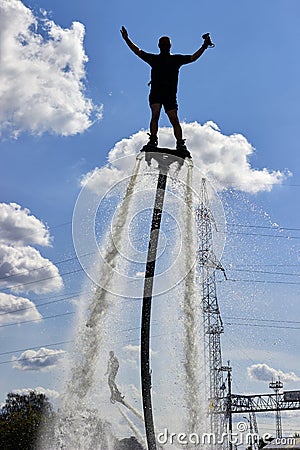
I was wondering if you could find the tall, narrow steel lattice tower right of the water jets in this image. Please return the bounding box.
[196,178,226,436]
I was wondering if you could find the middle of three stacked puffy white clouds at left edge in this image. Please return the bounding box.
[0,244,63,294]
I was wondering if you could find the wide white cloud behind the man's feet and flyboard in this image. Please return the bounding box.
[81,121,290,195]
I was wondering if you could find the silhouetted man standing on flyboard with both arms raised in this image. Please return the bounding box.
[120,27,213,150]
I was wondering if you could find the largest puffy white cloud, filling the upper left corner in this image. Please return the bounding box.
[0,0,101,137]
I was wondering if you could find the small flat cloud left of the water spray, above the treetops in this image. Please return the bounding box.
[12,347,66,372]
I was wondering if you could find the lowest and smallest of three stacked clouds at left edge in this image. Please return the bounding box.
[0,292,42,324]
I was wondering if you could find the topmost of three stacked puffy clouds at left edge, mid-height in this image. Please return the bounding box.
[0,203,51,246]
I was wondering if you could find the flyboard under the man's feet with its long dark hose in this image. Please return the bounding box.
[141,145,191,450]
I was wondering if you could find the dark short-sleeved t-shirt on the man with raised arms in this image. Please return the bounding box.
[139,50,192,93]
